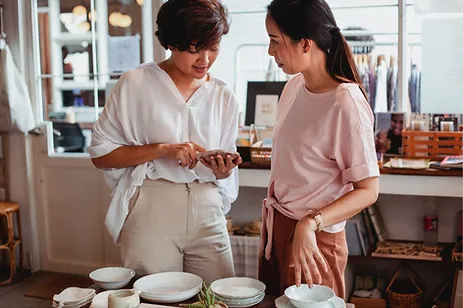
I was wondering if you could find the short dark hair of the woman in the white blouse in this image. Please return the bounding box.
[156,0,230,51]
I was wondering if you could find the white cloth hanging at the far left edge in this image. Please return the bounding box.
[0,46,35,133]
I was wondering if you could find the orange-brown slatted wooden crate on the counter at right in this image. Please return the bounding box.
[402,131,463,160]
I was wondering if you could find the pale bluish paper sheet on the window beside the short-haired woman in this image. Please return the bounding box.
[108,35,140,73]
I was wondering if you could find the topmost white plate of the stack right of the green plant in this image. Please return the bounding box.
[211,277,265,299]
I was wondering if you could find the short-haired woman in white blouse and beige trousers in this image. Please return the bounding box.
[89,0,241,283]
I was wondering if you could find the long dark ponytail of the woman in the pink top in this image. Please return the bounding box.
[326,27,368,101]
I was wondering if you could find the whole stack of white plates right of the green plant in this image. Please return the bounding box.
[211,277,265,308]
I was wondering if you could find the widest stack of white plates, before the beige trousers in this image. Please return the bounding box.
[133,272,203,304]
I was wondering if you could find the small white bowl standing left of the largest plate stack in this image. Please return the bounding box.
[89,267,135,290]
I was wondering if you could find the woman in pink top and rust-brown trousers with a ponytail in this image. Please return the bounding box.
[259,0,379,297]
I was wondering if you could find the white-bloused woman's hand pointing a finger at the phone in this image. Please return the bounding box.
[162,142,206,169]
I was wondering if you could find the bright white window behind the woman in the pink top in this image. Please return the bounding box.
[212,0,432,118]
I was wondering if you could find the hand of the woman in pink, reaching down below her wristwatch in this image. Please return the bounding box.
[290,217,328,287]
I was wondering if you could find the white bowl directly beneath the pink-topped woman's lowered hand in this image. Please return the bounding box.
[285,284,335,308]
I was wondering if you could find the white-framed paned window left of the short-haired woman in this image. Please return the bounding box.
[37,0,154,150]
